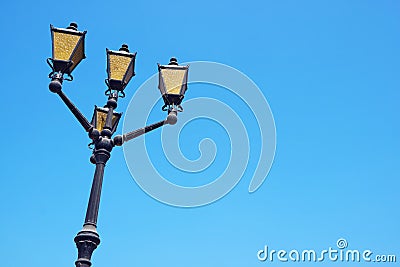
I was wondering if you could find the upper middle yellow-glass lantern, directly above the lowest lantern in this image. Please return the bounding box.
[106,44,136,96]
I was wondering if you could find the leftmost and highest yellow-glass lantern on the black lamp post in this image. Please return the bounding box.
[49,22,86,76]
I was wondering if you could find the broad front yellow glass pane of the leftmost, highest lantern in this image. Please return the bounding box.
[53,31,80,60]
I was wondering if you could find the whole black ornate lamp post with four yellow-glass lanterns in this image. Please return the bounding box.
[47,23,189,267]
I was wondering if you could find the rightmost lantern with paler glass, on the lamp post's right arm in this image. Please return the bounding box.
[158,58,189,107]
